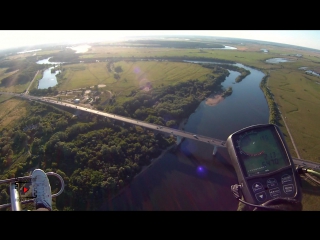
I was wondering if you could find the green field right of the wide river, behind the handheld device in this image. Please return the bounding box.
[268,69,320,162]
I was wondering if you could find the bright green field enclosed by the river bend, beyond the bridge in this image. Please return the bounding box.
[59,61,211,102]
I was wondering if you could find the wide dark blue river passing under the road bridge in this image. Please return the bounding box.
[101,63,269,211]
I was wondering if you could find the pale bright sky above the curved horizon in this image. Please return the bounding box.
[0,30,320,50]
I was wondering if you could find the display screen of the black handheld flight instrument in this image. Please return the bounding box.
[232,126,290,177]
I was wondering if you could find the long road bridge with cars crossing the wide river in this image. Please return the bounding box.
[0,92,320,170]
